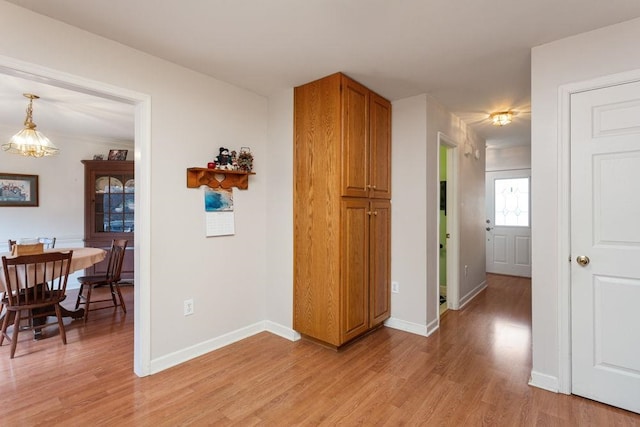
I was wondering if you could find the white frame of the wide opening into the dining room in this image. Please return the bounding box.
[0,55,151,377]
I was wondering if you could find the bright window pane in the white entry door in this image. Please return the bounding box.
[494,177,529,227]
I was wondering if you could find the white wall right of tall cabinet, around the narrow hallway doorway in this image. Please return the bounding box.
[388,95,486,335]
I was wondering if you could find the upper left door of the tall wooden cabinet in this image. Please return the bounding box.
[342,76,370,197]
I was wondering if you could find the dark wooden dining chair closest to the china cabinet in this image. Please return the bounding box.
[76,239,127,323]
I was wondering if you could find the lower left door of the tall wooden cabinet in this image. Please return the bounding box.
[340,199,370,343]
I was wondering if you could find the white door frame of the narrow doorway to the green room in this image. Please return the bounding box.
[434,132,460,318]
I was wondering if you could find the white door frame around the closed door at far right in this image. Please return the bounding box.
[556,70,640,394]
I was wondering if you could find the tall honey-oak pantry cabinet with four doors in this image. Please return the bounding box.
[293,73,391,347]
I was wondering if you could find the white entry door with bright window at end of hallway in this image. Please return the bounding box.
[486,169,531,277]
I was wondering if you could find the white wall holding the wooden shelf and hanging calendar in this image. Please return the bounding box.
[0,1,268,366]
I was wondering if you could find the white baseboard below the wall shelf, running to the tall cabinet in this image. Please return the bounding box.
[149,321,300,375]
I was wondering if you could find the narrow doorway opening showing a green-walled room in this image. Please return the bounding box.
[436,132,460,319]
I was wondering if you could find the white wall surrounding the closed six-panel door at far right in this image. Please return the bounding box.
[531,15,640,391]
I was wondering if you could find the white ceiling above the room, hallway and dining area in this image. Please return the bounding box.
[0,0,640,146]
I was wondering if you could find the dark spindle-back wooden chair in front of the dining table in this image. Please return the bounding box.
[0,251,73,359]
